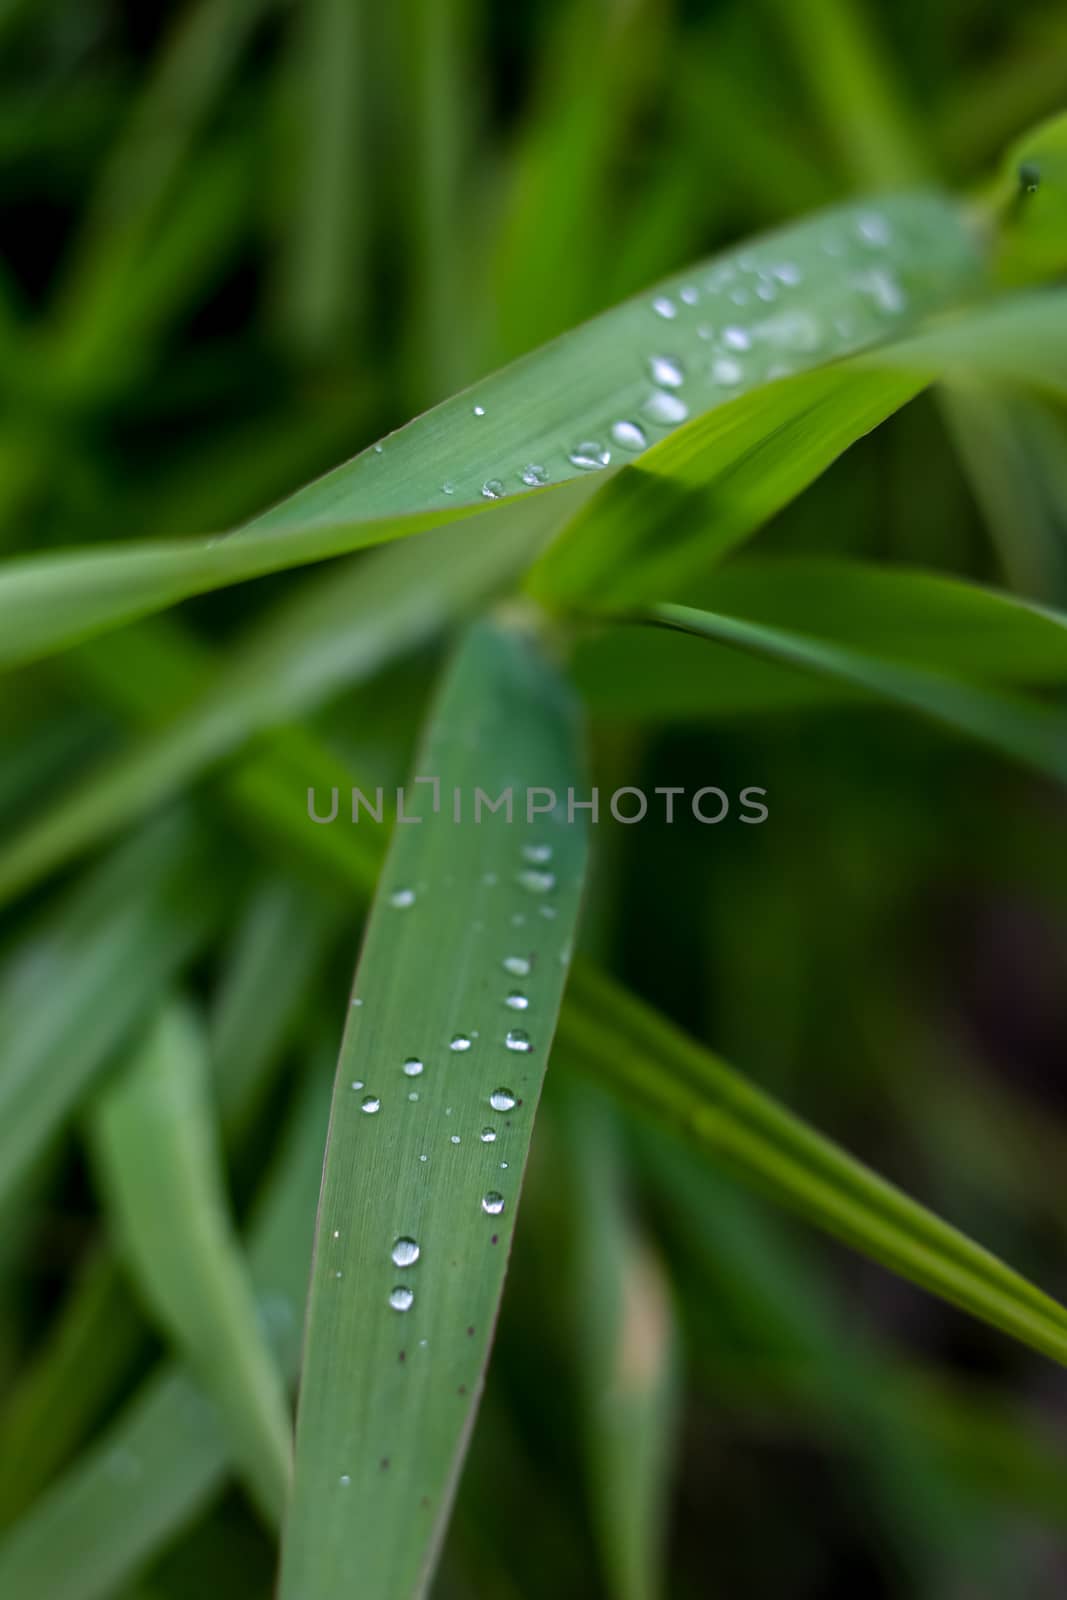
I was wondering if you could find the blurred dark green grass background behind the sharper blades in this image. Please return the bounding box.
[0,0,1067,1600]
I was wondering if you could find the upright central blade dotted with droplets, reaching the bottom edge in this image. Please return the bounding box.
[282,626,585,1600]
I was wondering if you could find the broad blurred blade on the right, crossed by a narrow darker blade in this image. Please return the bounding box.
[573,557,1067,718]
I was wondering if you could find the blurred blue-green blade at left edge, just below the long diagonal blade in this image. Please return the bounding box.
[0,818,218,1205]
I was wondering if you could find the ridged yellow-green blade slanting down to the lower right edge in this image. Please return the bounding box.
[560,966,1067,1365]
